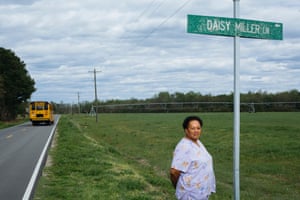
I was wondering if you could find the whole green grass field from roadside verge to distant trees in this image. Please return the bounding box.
[35,112,300,200]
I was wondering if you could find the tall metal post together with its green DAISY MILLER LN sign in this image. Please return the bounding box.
[187,0,283,200]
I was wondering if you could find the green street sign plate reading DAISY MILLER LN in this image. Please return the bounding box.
[187,15,283,40]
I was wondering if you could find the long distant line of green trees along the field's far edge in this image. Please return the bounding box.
[53,89,300,114]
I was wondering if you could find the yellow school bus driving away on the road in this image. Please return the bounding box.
[29,101,54,125]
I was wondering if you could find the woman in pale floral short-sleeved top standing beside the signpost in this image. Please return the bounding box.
[170,116,216,200]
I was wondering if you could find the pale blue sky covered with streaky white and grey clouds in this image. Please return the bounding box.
[0,0,300,103]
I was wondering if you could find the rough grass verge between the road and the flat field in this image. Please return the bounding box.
[35,116,172,200]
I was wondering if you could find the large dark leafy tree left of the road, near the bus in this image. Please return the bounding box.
[0,47,35,121]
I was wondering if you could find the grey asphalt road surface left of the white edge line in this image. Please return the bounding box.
[0,120,57,200]
